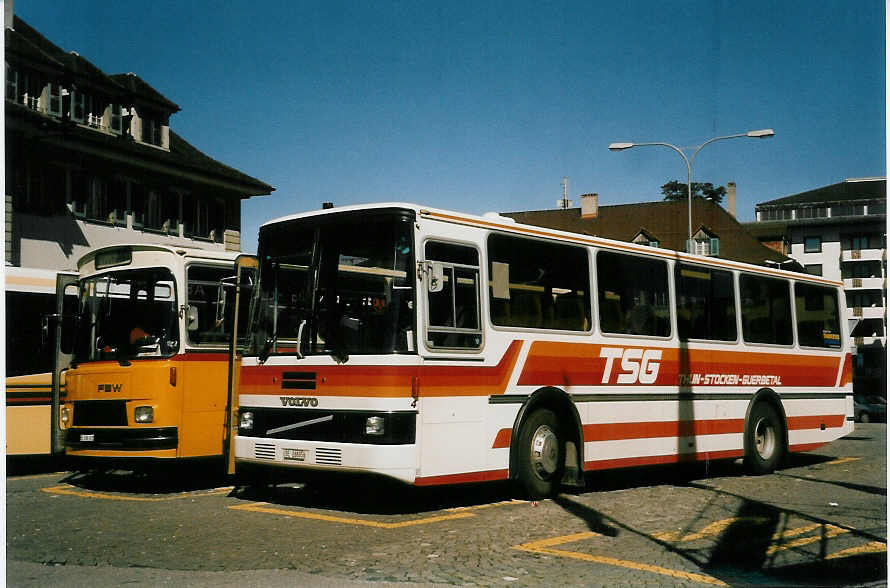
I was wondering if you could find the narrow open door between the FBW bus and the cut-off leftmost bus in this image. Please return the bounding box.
[44,272,80,455]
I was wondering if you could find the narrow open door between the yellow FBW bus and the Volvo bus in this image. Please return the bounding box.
[225,255,259,474]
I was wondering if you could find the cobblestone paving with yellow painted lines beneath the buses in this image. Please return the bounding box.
[6,425,887,586]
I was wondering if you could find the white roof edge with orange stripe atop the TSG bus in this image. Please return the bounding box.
[255,202,843,287]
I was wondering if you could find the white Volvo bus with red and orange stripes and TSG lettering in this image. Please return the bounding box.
[230,203,853,497]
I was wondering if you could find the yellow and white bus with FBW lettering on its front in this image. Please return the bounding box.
[60,244,238,465]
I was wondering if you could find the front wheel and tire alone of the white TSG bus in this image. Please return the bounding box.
[516,408,565,500]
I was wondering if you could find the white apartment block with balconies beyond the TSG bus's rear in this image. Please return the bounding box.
[747,178,887,396]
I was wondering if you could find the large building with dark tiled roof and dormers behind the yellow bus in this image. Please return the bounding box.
[5,9,273,270]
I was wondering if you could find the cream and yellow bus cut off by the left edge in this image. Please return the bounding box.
[4,267,70,456]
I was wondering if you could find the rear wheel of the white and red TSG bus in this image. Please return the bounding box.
[744,388,788,475]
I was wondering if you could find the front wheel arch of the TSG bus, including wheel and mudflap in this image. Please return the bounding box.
[510,388,584,499]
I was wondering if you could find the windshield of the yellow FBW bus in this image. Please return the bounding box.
[74,268,179,363]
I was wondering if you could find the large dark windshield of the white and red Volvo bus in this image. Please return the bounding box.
[248,213,415,362]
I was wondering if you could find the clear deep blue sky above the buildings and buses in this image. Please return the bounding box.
[15,0,886,251]
